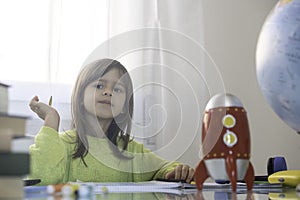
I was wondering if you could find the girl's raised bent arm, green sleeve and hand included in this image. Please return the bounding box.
[29,96,69,185]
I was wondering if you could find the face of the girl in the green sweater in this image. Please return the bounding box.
[83,68,126,119]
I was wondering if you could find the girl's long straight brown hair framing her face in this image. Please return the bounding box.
[71,58,133,164]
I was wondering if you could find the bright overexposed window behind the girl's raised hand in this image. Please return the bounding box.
[0,0,108,134]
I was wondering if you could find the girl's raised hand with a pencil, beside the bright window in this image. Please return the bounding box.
[29,96,60,130]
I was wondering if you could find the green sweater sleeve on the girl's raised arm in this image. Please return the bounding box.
[29,126,70,185]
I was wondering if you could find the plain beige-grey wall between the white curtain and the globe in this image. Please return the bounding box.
[199,0,300,174]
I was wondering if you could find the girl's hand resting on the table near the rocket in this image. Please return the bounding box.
[165,165,195,183]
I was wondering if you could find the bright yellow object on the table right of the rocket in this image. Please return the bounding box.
[268,170,300,187]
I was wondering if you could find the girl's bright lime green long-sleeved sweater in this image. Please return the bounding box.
[29,126,179,185]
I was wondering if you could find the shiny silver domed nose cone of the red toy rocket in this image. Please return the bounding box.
[205,93,244,110]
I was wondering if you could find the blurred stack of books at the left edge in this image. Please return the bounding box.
[0,83,30,199]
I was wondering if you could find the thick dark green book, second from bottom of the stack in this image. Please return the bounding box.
[0,152,30,176]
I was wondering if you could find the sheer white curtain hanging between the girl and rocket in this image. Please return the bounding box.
[101,0,213,166]
